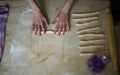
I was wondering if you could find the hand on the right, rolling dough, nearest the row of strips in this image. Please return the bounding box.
[52,12,70,36]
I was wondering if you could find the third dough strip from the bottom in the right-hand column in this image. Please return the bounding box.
[80,39,106,46]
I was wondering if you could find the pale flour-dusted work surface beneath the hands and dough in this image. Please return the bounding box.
[0,0,116,75]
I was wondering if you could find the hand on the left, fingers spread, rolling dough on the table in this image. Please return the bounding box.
[32,12,48,36]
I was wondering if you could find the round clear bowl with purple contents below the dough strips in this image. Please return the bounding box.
[87,55,106,73]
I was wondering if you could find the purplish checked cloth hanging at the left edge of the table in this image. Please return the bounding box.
[0,5,8,62]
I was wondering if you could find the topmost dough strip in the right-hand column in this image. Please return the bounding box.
[72,11,100,17]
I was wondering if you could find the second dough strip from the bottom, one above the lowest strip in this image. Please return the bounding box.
[78,45,106,52]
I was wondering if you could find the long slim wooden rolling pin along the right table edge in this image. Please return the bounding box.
[106,8,119,71]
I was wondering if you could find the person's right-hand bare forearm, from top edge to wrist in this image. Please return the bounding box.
[61,0,74,13]
